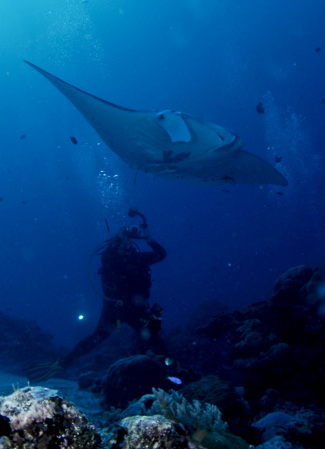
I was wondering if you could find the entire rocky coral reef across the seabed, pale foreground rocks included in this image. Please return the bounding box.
[0,266,325,449]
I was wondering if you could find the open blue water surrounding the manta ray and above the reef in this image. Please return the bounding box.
[0,0,325,346]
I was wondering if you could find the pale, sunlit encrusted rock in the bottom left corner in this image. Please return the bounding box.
[0,387,102,449]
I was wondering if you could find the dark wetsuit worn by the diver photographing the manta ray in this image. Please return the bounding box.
[61,235,166,366]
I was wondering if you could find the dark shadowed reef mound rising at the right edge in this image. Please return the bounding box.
[198,265,325,413]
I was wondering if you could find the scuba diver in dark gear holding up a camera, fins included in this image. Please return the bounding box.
[26,208,166,382]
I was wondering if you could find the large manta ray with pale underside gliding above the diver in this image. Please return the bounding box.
[25,61,288,186]
